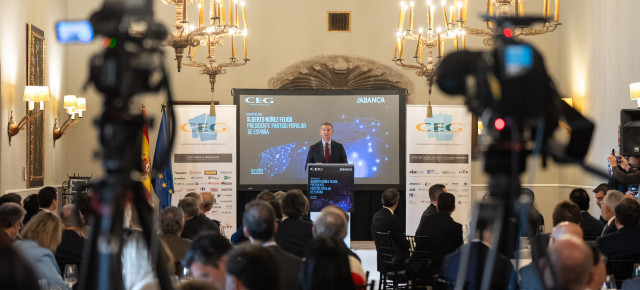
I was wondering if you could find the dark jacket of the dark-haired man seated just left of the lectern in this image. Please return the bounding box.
[276,218,313,258]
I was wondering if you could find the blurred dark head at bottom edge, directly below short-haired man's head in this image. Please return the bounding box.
[226,243,278,290]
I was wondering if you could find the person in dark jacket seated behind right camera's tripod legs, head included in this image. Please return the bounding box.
[442,210,516,290]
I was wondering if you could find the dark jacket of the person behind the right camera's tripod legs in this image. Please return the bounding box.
[442,242,516,290]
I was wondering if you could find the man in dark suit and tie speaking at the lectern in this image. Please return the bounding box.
[305,122,347,168]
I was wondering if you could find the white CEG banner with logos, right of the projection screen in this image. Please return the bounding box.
[406,105,472,235]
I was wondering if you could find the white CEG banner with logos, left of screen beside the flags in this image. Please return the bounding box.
[171,105,237,236]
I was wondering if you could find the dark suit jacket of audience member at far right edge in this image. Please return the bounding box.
[596,228,640,260]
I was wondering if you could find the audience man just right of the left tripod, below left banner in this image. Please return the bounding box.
[160,206,191,261]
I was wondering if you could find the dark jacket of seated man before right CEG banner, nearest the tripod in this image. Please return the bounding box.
[416,212,462,273]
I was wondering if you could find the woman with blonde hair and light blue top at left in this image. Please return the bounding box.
[14,211,69,289]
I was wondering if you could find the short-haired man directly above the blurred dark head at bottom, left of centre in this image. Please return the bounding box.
[242,200,302,290]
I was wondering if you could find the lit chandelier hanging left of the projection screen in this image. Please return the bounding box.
[161,0,249,111]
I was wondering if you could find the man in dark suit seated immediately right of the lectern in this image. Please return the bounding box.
[371,188,409,269]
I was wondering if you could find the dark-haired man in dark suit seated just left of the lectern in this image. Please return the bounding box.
[276,189,313,258]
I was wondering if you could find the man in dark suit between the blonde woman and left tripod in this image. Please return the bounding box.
[55,204,86,271]
